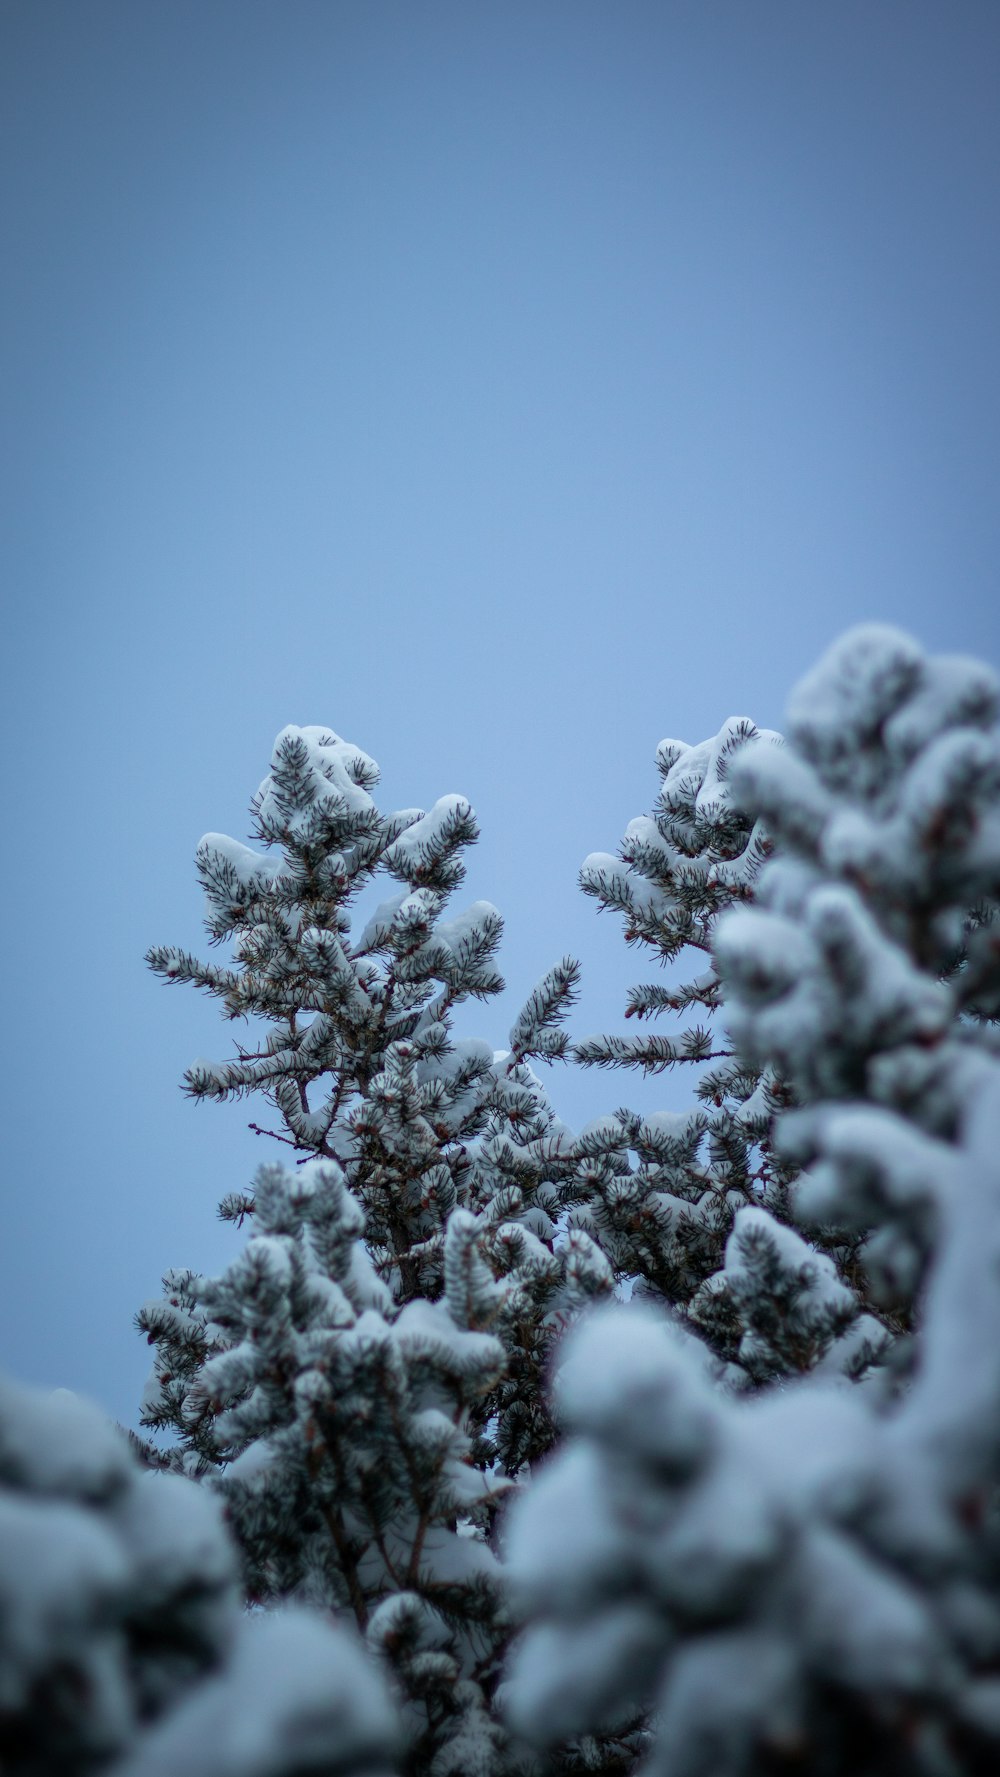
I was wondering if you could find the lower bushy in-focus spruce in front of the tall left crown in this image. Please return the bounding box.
[140,1160,515,1770]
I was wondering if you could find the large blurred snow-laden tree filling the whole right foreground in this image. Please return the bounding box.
[510,629,1000,1777]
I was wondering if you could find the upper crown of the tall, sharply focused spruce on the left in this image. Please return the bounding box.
[149,729,503,1297]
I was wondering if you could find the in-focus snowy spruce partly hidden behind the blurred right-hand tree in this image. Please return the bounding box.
[574,718,881,1390]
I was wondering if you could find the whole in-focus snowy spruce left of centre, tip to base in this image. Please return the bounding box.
[139,729,611,1777]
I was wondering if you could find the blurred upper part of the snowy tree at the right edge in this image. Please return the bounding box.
[718,627,1000,1326]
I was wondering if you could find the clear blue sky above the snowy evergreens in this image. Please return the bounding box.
[0,0,1000,1420]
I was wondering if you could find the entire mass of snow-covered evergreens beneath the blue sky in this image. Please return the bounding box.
[0,627,1000,1777]
